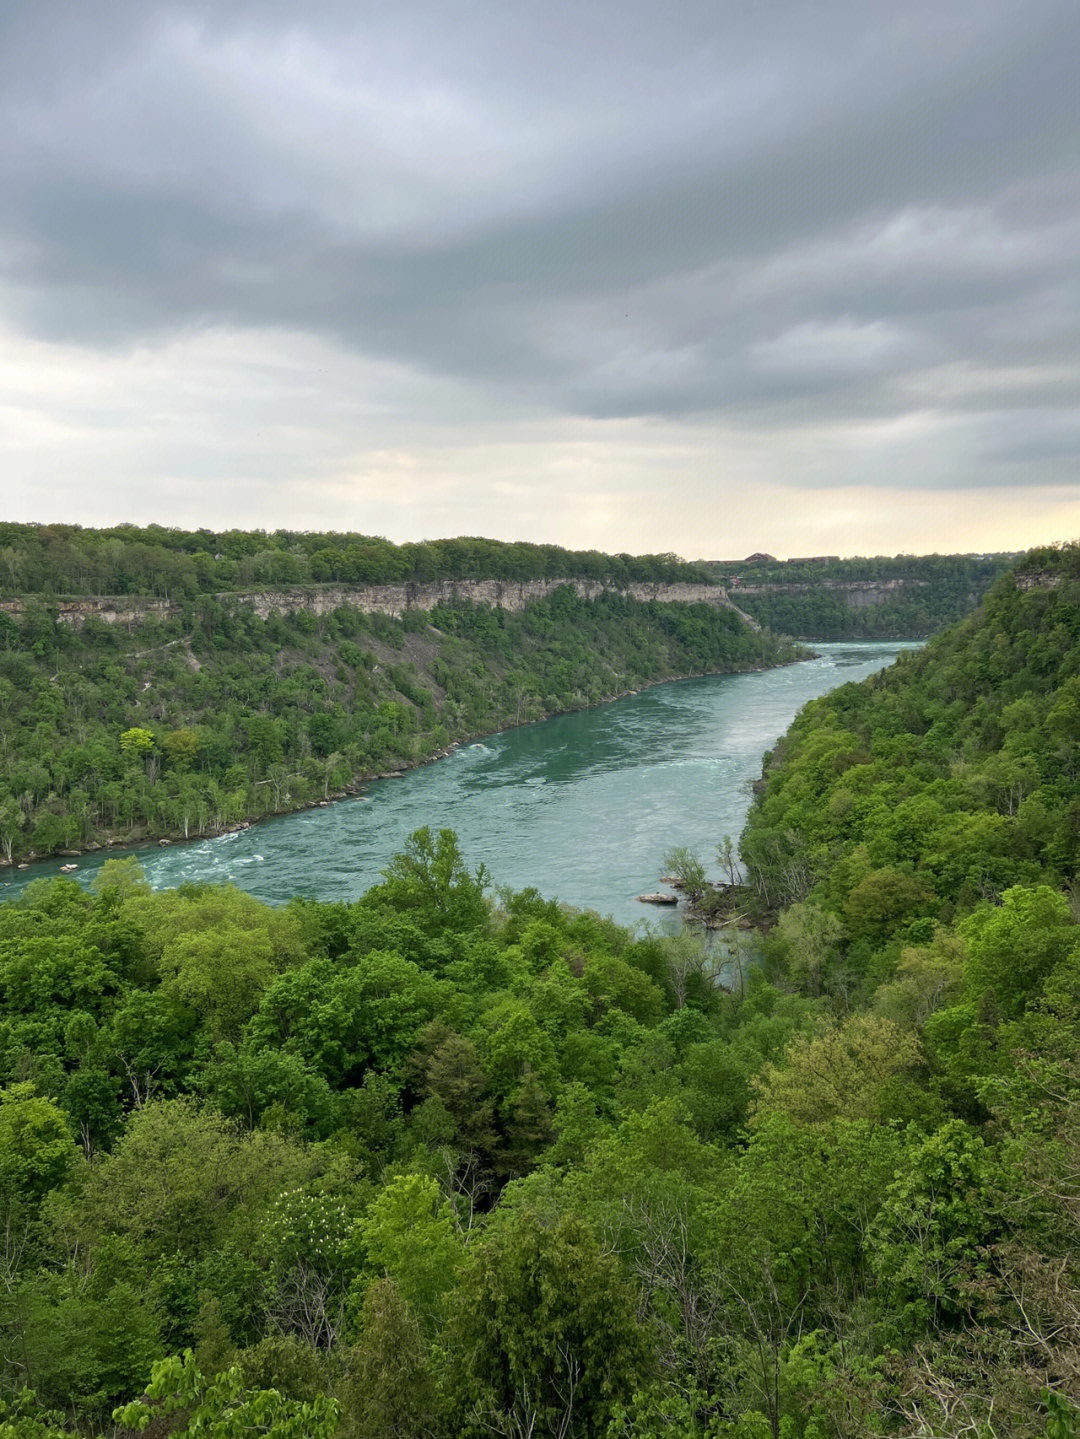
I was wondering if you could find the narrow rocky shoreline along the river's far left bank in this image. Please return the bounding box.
[0,646,817,872]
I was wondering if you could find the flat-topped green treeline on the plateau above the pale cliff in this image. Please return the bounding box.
[0,524,710,600]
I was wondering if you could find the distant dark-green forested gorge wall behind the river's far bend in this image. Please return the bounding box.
[709,554,1011,640]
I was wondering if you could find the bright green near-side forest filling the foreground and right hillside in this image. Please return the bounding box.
[0,547,1080,1439]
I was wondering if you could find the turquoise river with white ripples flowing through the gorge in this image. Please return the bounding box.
[0,642,913,924]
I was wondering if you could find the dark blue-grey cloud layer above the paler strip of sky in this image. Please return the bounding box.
[0,0,1080,469]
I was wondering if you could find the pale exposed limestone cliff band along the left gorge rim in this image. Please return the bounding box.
[0,580,759,629]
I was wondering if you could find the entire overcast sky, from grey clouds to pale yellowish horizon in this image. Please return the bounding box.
[0,0,1080,558]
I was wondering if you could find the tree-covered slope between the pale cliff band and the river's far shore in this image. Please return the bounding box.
[0,586,797,863]
